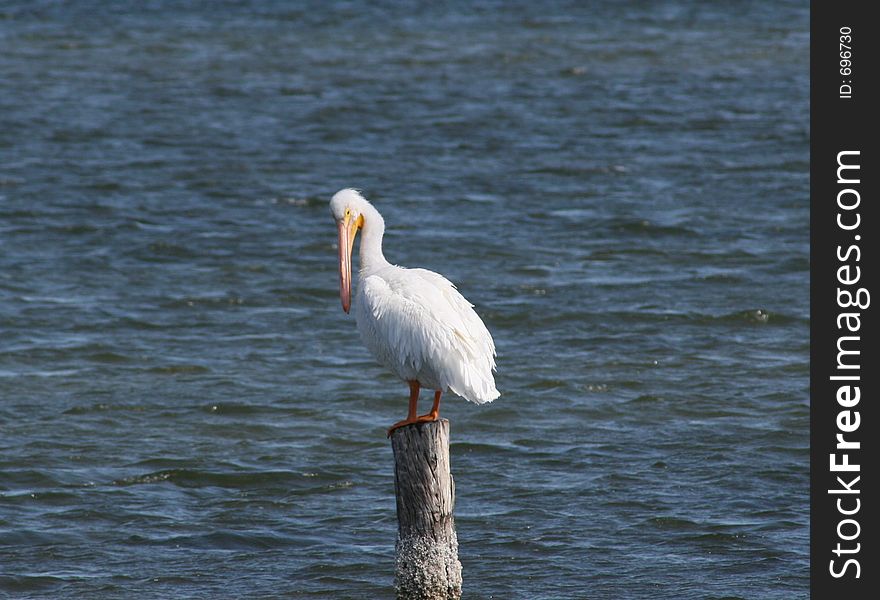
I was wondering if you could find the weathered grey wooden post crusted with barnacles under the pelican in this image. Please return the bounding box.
[391,419,461,600]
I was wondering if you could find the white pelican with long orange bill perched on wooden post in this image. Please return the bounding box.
[330,189,501,436]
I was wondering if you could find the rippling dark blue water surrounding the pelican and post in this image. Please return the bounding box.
[0,0,809,600]
